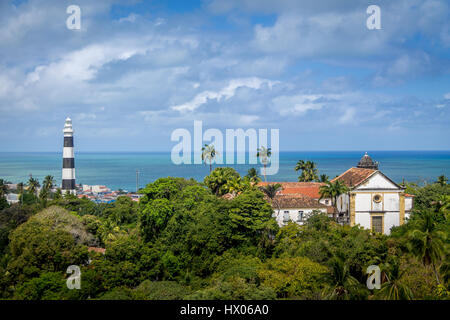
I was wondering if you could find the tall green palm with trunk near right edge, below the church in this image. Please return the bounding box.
[407,211,446,285]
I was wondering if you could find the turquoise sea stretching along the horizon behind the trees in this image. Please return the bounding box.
[0,151,450,191]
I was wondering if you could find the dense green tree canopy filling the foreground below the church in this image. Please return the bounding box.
[0,172,450,300]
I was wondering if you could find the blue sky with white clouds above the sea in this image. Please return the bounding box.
[0,0,450,152]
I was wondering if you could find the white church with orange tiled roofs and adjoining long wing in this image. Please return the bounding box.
[260,153,414,234]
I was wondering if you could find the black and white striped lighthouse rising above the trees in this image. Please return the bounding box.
[62,118,76,194]
